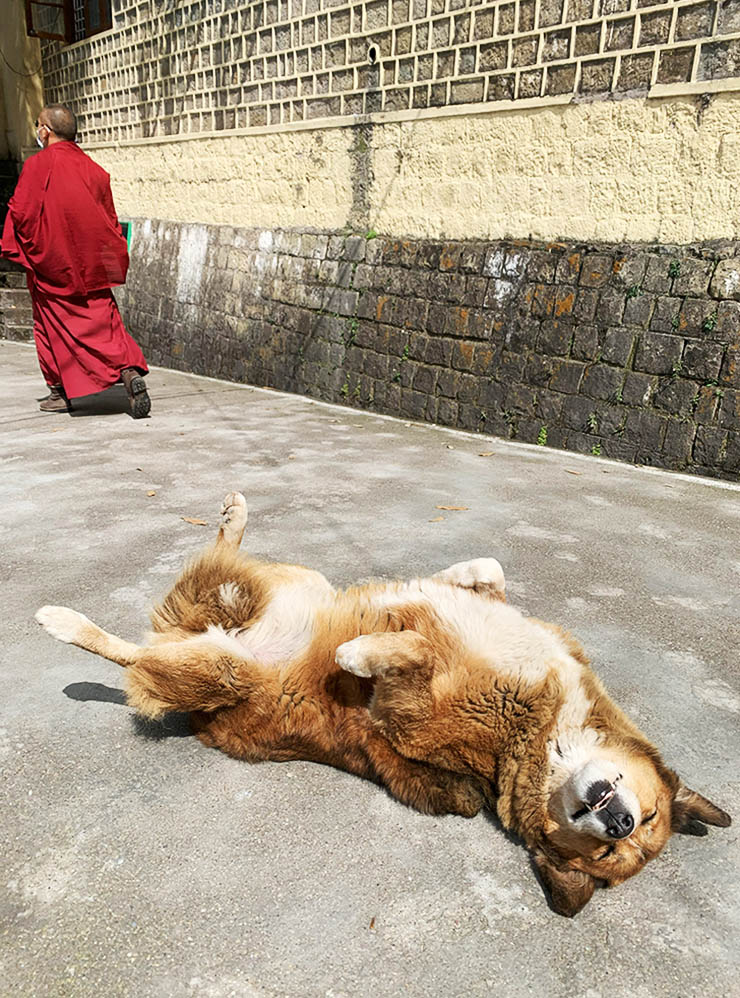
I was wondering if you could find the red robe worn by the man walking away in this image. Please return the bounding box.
[0,141,148,398]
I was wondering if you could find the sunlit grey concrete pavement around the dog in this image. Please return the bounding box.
[0,342,740,998]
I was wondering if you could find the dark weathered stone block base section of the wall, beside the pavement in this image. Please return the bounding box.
[118,220,740,480]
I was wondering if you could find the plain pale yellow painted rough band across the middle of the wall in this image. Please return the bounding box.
[89,92,740,243]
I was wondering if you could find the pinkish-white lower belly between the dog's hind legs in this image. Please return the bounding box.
[206,573,334,668]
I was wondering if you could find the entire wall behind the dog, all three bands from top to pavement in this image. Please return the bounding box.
[31,0,740,480]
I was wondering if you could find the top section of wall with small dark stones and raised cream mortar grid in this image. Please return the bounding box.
[44,0,740,144]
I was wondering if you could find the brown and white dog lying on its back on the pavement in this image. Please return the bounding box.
[36,493,730,915]
